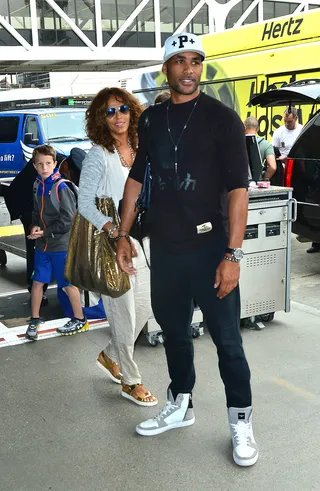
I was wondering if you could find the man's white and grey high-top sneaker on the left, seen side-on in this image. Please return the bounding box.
[136,389,195,436]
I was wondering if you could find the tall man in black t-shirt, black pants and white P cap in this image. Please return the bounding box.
[117,33,258,466]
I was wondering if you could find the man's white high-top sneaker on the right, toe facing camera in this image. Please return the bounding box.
[228,406,259,467]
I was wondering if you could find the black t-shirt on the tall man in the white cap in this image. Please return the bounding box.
[130,93,248,250]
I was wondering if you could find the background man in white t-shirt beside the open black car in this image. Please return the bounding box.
[272,106,302,164]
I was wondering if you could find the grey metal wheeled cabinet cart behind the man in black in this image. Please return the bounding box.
[240,186,297,329]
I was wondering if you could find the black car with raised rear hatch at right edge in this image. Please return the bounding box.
[250,79,320,243]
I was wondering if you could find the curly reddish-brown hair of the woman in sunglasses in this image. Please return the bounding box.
[86,87,144,153]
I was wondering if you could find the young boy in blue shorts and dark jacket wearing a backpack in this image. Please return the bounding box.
[25,145,89,341]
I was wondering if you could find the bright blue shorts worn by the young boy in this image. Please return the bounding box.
[32,249,71,288]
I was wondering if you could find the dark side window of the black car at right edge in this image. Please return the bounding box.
[290,113,320,159]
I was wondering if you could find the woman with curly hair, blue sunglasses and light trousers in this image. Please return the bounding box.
[79,87,158,406]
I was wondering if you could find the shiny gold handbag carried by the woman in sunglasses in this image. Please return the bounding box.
[64,198,130,298]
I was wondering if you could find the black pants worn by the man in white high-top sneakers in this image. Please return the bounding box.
[151,233,251,407]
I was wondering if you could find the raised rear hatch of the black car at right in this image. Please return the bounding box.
[249,79,320,107]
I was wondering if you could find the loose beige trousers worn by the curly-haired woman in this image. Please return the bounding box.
[102,239,151,385]
